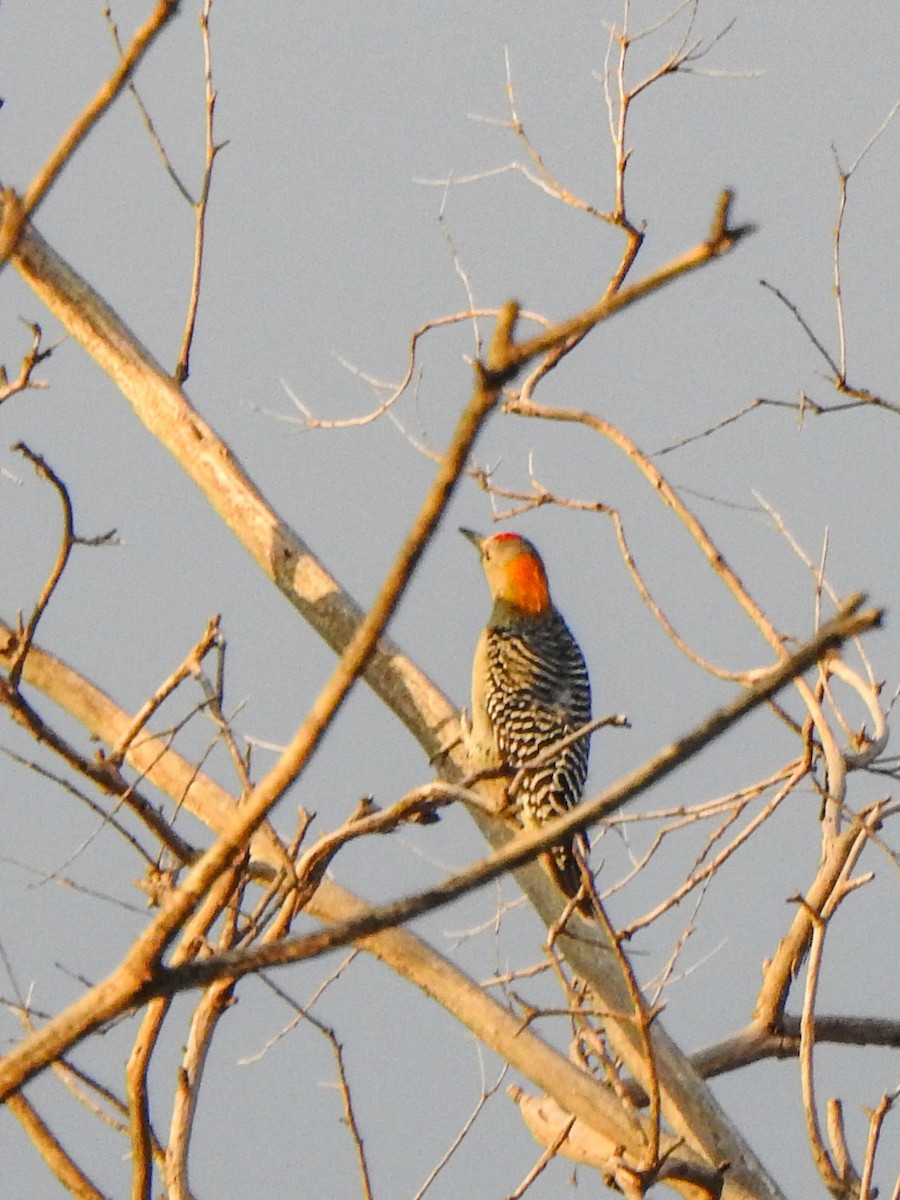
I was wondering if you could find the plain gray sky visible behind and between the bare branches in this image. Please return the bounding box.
[0,0,900,1200]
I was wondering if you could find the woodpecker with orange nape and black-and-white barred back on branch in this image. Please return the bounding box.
[460,529,592,912]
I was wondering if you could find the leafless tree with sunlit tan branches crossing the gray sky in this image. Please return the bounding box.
[0,0,900,1200]
